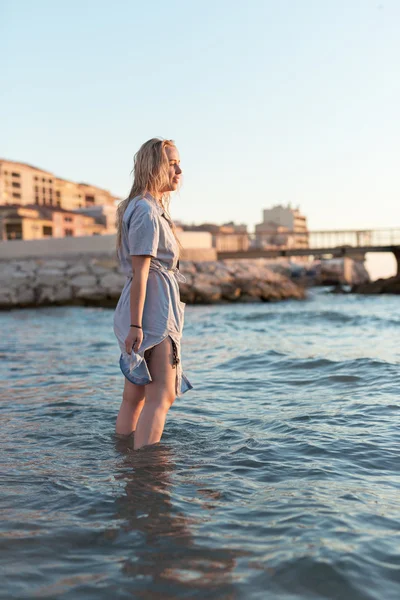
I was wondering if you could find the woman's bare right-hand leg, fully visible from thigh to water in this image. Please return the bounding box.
[134,337,176,450]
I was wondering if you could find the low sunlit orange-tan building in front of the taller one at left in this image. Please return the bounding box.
[0,204,104,241]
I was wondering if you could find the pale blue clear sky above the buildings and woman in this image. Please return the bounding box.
[0,0,400,276]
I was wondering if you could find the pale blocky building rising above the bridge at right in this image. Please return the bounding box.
[255,204,308,248]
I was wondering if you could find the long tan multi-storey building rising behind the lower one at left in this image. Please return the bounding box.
[0,160,117,239]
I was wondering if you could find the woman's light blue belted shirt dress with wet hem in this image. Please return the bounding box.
[114,193,193,396]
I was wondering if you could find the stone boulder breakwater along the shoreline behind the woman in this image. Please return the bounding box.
[0,254,305,310]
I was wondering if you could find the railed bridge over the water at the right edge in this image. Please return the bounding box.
[217,228,400,275]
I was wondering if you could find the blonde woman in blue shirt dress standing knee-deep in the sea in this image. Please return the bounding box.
[114,138,193,450]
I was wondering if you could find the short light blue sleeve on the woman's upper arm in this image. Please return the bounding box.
[128,202,160,257]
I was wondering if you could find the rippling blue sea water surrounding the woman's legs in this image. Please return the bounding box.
[0,292,400,600]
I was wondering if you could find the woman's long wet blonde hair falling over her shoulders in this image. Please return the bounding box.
[115,138,182,250]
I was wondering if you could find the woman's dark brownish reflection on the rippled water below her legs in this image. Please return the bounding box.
[115,440,239,599]
